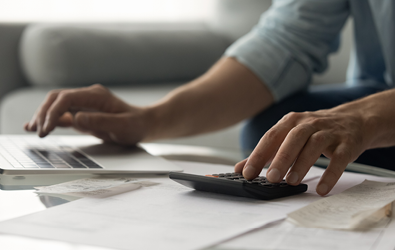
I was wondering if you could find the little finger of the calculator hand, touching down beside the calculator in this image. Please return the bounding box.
[316,144,352,196]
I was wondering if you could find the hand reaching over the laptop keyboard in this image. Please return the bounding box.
[24,84,147,145]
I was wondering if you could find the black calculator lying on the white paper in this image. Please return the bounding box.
[169,172,307,200]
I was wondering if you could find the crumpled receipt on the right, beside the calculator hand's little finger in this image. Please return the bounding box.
[287,180,395,229]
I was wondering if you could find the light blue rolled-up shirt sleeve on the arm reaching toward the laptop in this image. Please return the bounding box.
[225,0,349,102]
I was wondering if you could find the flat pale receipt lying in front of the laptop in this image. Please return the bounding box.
[36,177,157,200]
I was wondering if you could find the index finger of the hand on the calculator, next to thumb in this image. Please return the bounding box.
[243,118,294,180]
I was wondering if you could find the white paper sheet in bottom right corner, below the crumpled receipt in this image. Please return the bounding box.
[218,215,395,250]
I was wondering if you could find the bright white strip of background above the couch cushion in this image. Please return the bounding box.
[0,0,215,22]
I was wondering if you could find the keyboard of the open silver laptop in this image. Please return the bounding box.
[0,140,103,169]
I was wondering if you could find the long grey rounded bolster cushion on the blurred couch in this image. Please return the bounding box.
[21,24,230,86]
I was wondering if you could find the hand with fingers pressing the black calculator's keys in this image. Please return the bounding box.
[235,105,370,195]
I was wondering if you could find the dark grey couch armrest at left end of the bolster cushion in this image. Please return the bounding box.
[0,23,28,98]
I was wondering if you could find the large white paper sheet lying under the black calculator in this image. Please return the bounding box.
[0,163,319,250]
